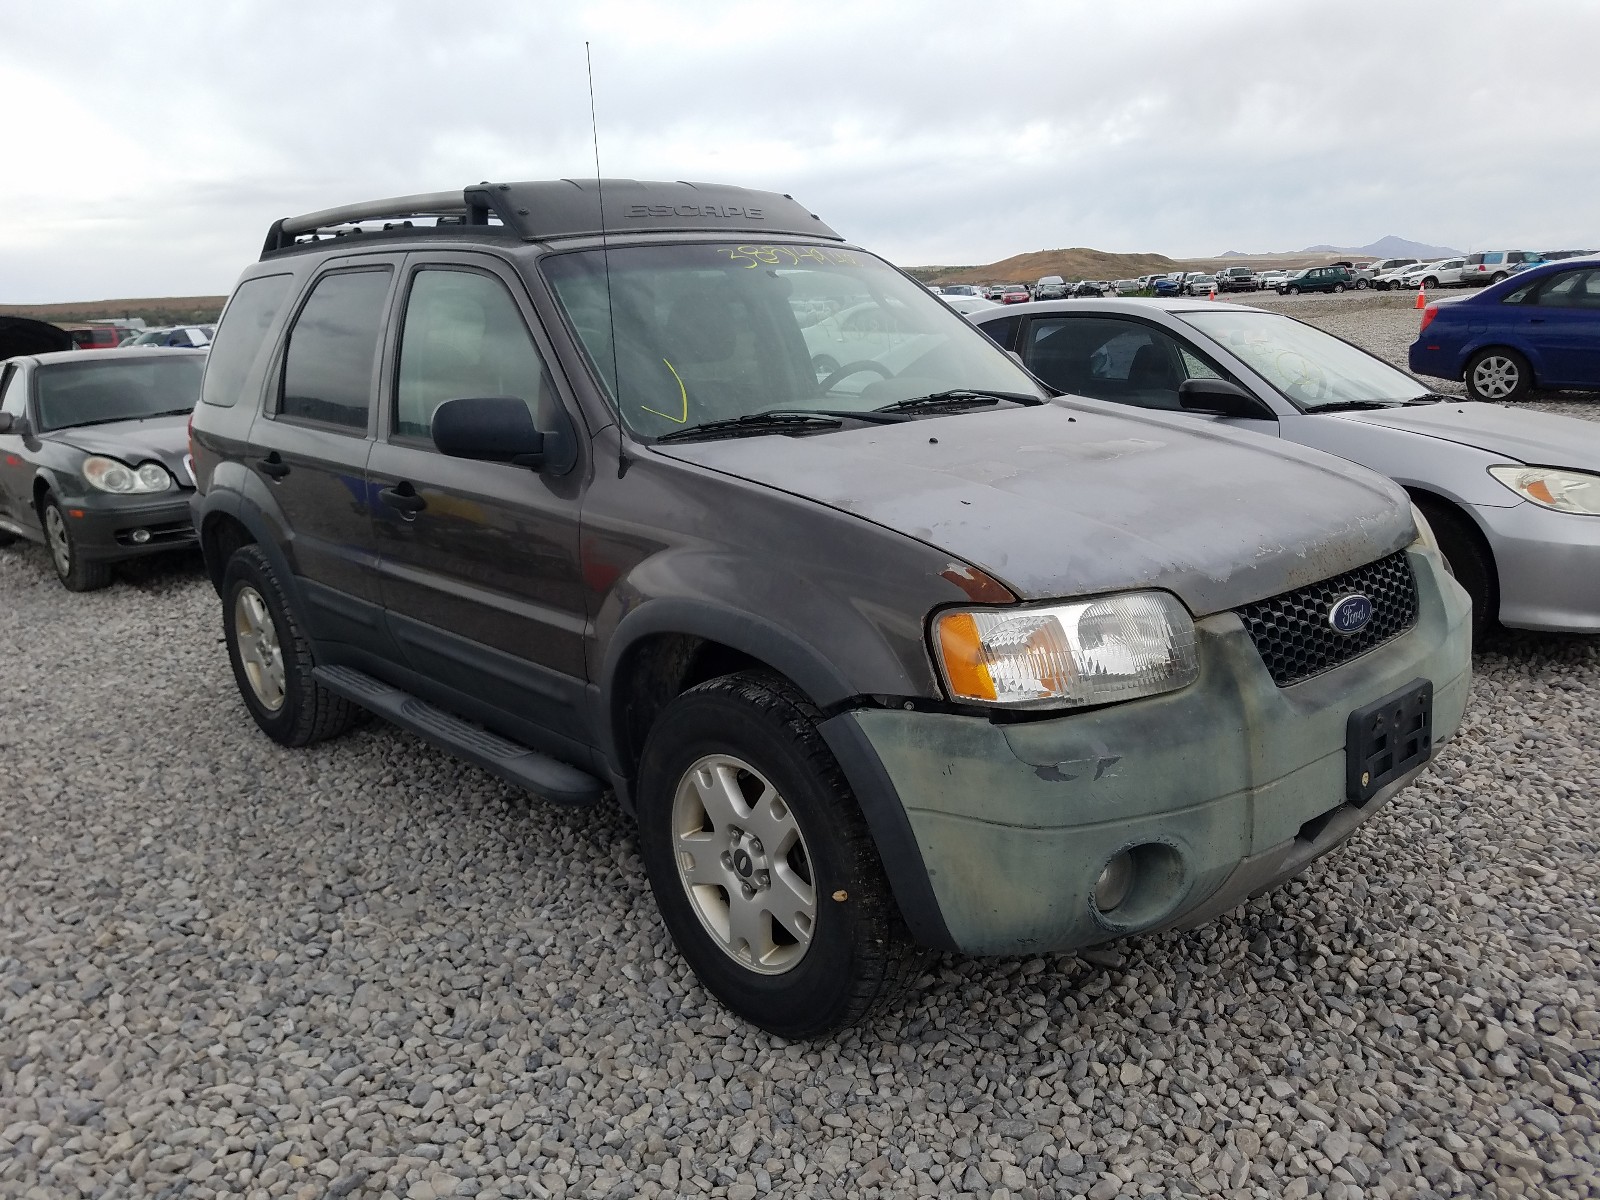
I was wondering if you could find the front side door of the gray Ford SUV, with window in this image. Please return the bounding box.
[368,253,587,749]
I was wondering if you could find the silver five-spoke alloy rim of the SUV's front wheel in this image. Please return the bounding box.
[672,754,816,974]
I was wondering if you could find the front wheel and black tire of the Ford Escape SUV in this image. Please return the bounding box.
[638,672,923,1038]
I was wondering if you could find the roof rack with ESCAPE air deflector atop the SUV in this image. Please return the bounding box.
[261,179,843,258]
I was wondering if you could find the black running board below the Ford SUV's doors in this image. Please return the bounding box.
[312,667,605,805]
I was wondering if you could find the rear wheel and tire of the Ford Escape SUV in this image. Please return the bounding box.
[222,546,362,746]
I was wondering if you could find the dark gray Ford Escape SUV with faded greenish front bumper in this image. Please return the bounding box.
[192,181,1469,1037]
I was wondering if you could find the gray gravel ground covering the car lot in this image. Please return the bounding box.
[0,320,1600,1200]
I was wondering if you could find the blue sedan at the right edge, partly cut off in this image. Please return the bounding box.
[1411,256,1600,400]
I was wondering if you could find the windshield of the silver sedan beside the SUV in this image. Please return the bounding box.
[1176,310,1430,411]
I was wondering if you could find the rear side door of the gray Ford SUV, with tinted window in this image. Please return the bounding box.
[246,254,402,648]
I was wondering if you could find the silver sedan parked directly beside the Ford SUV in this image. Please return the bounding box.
[970,299,1600,634]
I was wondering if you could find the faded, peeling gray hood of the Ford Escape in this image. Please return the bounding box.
[656,400,1413,616]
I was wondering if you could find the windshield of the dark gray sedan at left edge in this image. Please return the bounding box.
[35,350,205,430]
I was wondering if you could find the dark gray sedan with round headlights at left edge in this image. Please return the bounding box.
[0,350,205,592]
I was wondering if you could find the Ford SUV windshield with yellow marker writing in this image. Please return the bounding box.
[541,243,1043,437]
